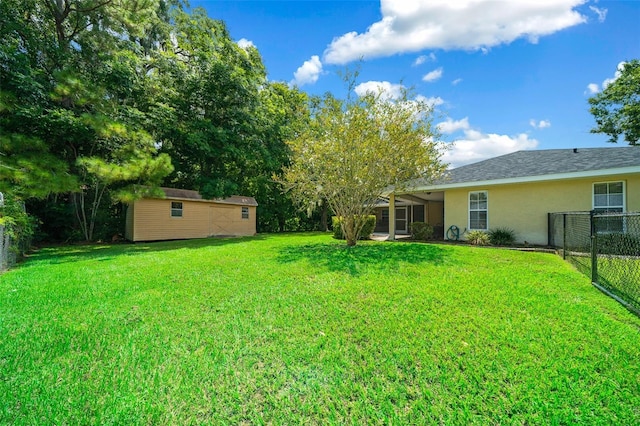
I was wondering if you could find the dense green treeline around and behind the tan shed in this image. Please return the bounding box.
[0,0,318,241]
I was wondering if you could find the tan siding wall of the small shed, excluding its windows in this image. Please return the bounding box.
[126,199,256,241]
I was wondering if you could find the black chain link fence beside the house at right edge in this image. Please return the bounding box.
[549,211,640,315]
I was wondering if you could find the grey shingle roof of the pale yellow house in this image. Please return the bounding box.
[434,146,640,185]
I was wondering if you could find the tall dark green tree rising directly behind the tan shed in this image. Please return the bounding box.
[156,9,266,198]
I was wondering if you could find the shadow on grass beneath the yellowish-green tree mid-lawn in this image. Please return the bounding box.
[277,243,449,276]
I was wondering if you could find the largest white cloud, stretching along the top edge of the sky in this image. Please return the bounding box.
[324,0,587,64]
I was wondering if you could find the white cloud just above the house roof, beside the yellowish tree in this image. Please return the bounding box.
[437,117,538,168]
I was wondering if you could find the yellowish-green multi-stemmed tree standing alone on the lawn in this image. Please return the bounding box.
[284,76,445,246]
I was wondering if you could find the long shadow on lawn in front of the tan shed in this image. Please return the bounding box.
[28,234,268,264]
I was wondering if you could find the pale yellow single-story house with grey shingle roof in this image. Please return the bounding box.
[376,146,640,245]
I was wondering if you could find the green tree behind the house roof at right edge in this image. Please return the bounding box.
[589,59,640,145]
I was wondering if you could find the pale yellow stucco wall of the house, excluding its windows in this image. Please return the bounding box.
[444,175,640,245]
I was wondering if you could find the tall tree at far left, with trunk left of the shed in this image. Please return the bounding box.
[0,0,176,239]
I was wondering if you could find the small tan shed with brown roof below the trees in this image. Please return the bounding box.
[125,188,258,241]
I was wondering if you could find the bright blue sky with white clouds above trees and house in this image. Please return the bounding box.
[190,0,640,166]
